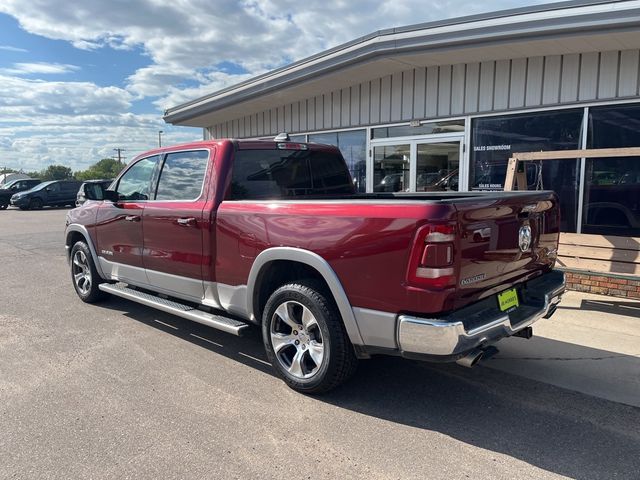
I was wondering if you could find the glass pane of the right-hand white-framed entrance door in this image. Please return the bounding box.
[416,142,460,192]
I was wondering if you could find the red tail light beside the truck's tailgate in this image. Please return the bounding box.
[407,223,457,289]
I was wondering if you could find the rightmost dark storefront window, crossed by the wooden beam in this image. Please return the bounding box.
[582,105,640,236]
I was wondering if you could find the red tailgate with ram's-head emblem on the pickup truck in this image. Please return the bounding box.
[455,191,560,306]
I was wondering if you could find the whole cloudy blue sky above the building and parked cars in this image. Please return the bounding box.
[0,0,544,171]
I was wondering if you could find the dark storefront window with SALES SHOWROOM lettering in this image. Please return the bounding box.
[470,109,583,232]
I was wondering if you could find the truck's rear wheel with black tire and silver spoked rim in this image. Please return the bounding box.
[262,281,358,394]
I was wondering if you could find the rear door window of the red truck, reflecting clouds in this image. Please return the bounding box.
[156,150,209,200]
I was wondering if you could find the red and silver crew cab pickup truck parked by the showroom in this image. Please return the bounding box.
[65,137,564,393]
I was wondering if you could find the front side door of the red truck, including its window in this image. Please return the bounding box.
[96,155,159,285]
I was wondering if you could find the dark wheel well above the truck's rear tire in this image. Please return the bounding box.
[253,260,333,323]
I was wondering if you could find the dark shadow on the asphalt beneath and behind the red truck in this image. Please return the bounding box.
[100,298,640,479]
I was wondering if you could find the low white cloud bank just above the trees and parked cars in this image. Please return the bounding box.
[0,75,201,171]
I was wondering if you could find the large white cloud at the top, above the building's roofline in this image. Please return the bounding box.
[0,0,556,106]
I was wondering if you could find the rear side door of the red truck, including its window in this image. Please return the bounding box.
[142,149,210,301]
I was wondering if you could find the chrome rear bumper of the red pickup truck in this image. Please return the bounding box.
[397,270,565,360]
